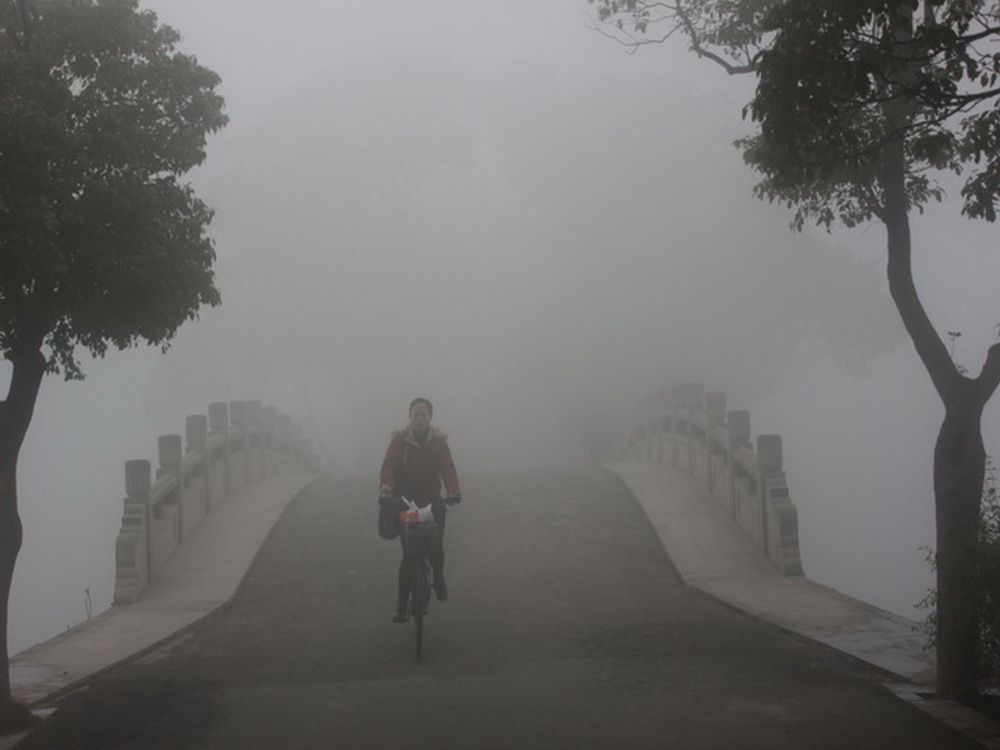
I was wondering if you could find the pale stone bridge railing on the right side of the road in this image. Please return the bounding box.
[619,384,802,576]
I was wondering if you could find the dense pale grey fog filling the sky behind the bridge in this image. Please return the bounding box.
[0,0,1000,651]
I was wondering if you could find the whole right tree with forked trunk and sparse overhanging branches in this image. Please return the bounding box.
[590,0,1000,698]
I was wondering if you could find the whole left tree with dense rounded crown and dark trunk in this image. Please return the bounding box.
[0,0,227,725]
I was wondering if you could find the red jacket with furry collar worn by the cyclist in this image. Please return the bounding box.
[379,427,461,508]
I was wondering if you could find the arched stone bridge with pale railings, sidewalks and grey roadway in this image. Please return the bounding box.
[0,394,1000,750]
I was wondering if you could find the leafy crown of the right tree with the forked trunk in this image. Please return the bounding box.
[590,0,1000,227]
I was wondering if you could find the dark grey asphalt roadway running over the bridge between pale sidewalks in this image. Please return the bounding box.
[19,469,976,750]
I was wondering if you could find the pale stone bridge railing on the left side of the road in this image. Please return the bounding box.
[114,401,319,604]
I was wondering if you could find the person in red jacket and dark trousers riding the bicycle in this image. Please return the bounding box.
[379,398,462,622]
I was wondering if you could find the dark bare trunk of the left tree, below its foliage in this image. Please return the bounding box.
[0,349,45,728]
